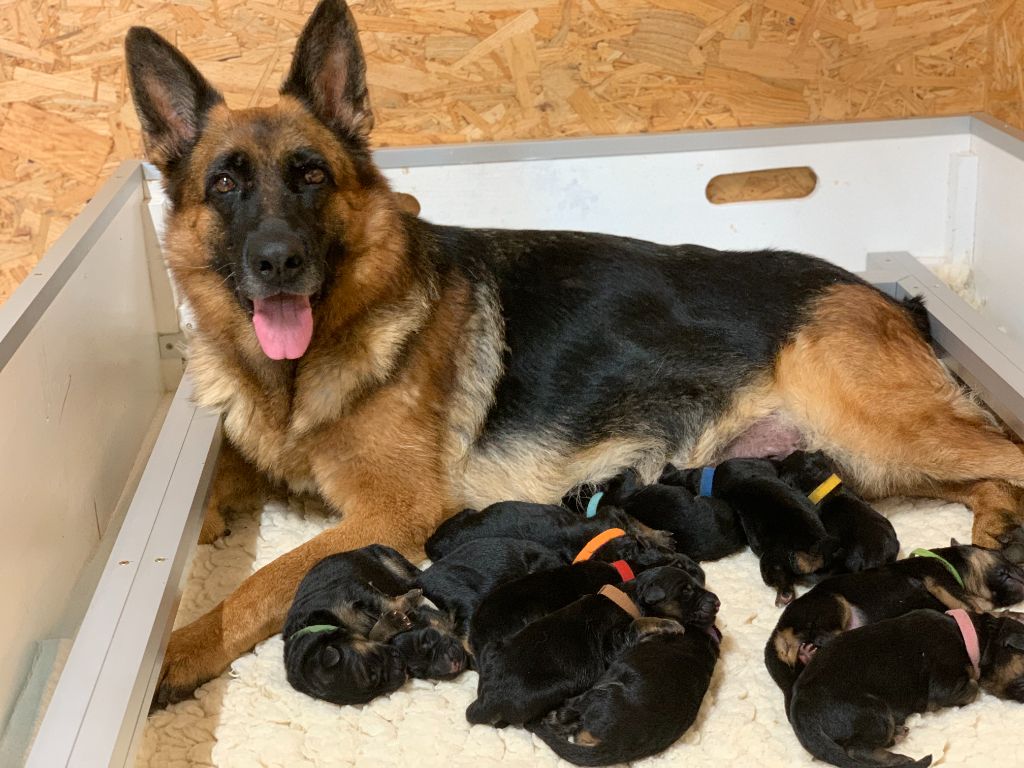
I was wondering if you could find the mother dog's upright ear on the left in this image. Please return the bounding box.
[125,27,224,171]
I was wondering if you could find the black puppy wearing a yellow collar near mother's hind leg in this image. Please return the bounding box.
[777,451,899,572]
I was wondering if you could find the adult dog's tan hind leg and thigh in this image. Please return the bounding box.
[775,286,1024,547]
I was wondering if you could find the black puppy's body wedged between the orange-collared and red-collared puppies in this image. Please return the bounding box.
[416,538,563,637]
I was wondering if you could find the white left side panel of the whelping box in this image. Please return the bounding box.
[0,169,164,722]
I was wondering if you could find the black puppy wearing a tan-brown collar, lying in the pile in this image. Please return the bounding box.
[466,566,718,725]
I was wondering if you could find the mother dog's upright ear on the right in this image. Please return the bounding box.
[281,0,374,141]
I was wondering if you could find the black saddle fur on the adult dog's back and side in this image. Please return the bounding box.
[432,234,862,456]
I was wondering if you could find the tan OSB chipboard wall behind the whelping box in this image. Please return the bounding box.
[0,0,1024,307]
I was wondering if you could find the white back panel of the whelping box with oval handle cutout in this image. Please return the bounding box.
[386,134,970,269]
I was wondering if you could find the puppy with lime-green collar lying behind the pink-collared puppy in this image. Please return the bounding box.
[765,542,1024,703]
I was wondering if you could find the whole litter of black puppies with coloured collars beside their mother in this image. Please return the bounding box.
[284,452,1024,765]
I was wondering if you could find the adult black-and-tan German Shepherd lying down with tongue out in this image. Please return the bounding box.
[125,0,1024,705]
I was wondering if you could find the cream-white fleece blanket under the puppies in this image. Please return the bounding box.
[138,500,1024,768]
